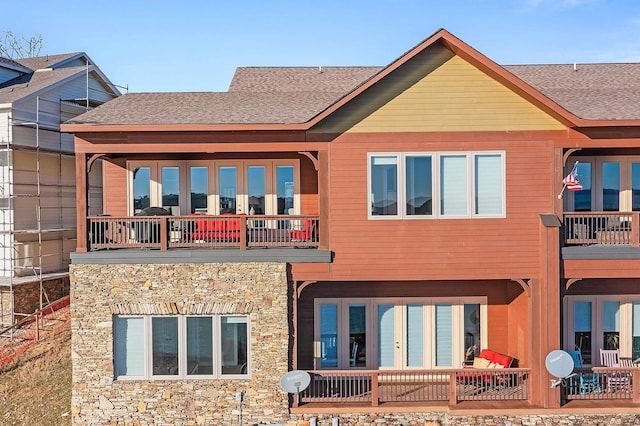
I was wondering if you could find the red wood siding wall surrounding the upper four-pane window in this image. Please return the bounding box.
[330,134,555,280]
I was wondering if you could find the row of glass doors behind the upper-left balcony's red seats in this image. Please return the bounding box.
[128,159,300,216]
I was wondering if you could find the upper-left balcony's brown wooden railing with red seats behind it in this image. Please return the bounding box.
[87,215,319,250]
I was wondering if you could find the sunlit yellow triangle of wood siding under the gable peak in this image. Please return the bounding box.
[349,56,564,132]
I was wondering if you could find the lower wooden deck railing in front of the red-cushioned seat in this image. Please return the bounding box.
[294,368,530,406]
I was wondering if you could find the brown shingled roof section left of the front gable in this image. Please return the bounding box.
[70,67,381,124]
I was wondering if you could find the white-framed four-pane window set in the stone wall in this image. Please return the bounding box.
[113,315,249,379]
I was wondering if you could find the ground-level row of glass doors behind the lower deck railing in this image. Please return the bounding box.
[314,297,487,369]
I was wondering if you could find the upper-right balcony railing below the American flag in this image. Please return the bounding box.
[563,212,640,247]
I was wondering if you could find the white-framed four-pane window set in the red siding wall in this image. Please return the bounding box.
[368,152,505,219]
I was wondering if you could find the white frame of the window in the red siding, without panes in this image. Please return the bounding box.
[367,150,507,220]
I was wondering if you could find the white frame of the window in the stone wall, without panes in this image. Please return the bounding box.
[112,314,251,381]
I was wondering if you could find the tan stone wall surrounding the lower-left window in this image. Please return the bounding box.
[70,263,289,425]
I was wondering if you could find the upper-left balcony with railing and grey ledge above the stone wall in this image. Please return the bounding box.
[72,214,331,263]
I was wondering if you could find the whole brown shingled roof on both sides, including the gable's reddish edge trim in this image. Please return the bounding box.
[69,30,640,125]
